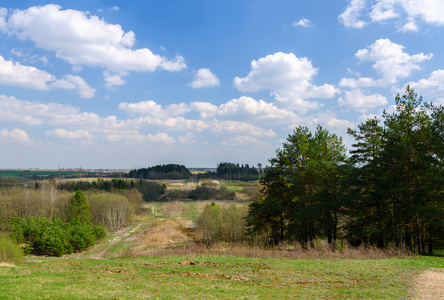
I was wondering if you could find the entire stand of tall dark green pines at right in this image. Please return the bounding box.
[247,87,444,254]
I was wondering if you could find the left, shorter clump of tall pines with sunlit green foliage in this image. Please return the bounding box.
[247,126,345,245]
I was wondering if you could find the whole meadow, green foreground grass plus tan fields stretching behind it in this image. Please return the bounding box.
[0,178,444,299]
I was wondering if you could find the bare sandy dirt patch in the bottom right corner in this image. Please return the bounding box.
[413,269,444,300]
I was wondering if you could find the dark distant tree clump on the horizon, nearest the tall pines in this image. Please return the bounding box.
[199,162,262,181]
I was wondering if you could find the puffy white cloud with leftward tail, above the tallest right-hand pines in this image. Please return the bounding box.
[339,39,433,88]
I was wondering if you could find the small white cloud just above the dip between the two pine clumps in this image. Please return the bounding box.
[338,90,387,112]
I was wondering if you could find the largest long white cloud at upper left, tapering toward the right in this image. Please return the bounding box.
[0,4,186,72]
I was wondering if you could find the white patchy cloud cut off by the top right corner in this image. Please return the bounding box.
[339,0,444,31]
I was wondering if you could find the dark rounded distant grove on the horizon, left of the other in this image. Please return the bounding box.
[128,164,191,179]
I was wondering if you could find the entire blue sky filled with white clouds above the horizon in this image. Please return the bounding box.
[0,0,444,169]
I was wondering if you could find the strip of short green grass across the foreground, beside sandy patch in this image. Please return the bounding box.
[0,255,444,299]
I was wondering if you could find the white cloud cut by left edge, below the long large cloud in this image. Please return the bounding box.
[0,55,56,90]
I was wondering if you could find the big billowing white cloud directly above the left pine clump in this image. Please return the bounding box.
[234,52,339,112]
